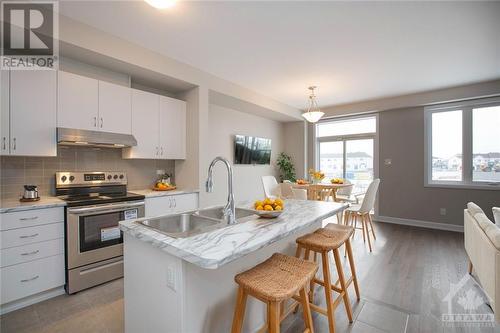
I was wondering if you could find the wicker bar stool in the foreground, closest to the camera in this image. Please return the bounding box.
[231,253,318,333]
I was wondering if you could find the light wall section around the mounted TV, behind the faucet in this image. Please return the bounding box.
[201,104,284,206]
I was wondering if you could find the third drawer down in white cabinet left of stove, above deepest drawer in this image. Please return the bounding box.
[0,238,64,267]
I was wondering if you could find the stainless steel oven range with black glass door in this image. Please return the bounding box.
[56,172,144,294]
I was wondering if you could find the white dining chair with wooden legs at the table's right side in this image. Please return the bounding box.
[344,178,380,252]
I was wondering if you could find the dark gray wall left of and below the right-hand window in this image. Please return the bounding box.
[378,107,500,225]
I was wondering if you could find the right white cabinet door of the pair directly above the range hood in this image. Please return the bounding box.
[99,81,132,134]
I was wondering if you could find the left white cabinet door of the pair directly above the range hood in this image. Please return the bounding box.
[57,72,99,131]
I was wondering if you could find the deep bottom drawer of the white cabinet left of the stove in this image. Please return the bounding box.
[0,254,64,304]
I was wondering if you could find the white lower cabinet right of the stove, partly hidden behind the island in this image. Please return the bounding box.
[145,193,198,217]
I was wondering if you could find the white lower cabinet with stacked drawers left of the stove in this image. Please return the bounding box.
[0,207,65,312]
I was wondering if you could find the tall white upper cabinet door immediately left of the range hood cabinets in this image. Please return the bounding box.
[10,70,57,156]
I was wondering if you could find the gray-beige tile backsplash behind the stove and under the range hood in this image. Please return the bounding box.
[0,146,174,199]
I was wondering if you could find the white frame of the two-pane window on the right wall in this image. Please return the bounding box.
[424,97,500,190]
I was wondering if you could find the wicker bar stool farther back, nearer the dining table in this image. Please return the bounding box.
[296,223,360,333]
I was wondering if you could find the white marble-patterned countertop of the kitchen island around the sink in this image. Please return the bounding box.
[120,200,348,269]
